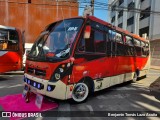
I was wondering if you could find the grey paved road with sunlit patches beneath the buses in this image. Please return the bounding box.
[0,70,160,120]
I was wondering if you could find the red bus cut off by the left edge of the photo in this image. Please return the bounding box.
[0,25,24,74]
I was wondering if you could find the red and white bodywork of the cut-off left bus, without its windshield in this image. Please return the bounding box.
[0,25,24,73]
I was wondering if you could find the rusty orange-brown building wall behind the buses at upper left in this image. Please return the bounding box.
[0,0,78,43]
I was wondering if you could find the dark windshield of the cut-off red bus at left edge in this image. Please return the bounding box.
[0,29,18,51]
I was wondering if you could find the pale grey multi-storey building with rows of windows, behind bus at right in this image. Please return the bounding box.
[109,0,160,66]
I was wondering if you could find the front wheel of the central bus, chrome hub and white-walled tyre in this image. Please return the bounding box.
[72,82,89,103]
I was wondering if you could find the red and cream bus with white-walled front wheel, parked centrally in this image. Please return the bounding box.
[24,16,150,103]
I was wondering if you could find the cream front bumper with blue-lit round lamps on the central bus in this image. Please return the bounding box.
[24,73,68,100]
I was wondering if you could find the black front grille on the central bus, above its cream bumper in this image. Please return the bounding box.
[27,67,46,76]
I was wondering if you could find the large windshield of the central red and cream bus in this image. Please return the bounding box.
[29,19,83,58]
